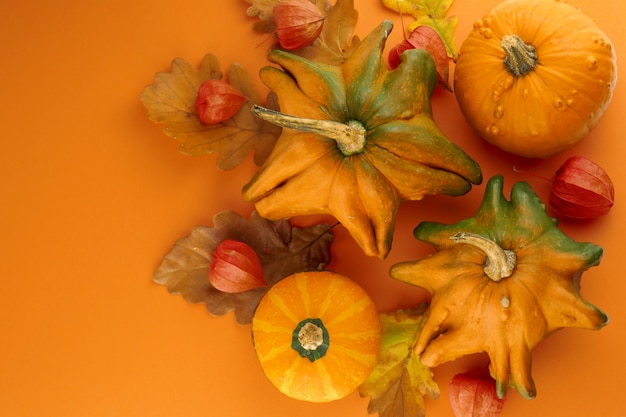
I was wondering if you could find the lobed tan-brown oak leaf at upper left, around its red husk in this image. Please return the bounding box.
[141,54,280,170]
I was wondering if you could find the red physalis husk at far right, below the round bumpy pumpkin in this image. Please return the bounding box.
[550,156,615,219]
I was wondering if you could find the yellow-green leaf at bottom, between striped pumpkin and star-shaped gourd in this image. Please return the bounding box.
[359,303,439,417]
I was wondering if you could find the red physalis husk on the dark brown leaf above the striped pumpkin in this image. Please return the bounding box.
[209,239,267,293]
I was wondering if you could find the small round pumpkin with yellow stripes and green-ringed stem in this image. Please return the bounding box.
[252,271,381,402]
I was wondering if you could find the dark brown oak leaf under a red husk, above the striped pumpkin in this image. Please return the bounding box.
[153,210,334,324]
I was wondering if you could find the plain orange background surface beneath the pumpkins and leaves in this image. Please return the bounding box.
[0,0,626,417]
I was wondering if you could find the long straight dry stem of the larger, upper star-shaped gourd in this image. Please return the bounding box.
[252,104,367,156]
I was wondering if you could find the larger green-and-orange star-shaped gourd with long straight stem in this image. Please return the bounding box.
[243,21,482,258]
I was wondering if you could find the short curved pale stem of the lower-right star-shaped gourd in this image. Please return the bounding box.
[450,232,517,282]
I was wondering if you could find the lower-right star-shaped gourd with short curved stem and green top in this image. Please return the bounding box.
[390,175,608,398]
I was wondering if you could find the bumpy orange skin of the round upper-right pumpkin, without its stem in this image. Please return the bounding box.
[454,0,617,158]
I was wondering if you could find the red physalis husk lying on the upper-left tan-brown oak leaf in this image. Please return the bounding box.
[196,80,247,124]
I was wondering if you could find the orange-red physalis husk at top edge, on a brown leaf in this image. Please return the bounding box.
[273,0,325,50]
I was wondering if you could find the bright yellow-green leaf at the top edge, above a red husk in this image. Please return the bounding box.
[380,0,459,58]
